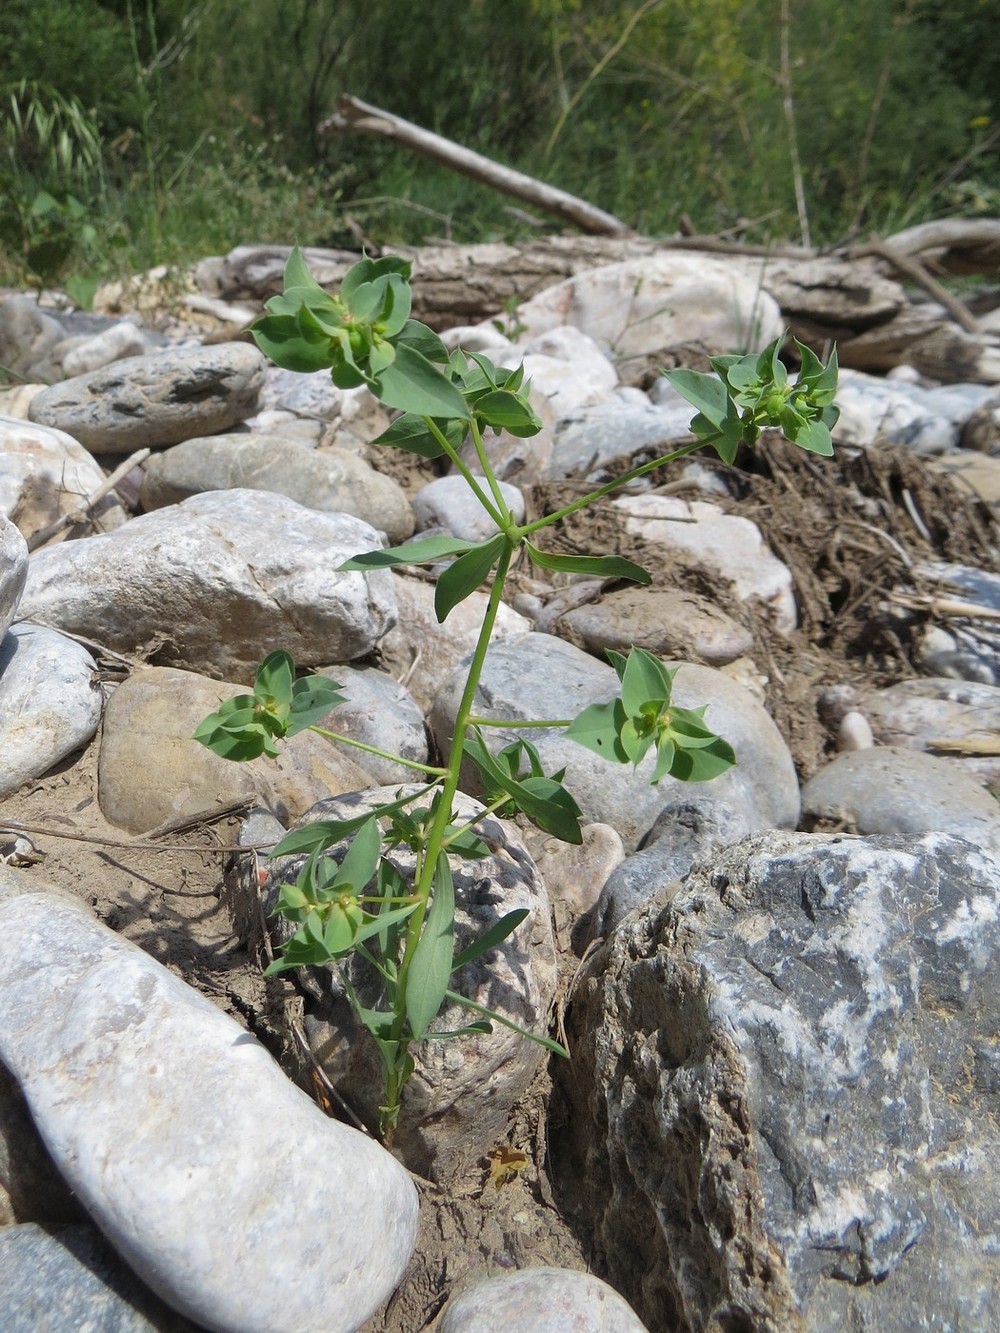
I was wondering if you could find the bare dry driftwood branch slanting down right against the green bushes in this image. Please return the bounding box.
[319,93,633,236]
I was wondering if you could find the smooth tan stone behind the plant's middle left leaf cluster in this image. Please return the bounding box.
[97,667,372,833]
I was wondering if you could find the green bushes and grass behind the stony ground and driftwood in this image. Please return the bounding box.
[0,0,1000,291]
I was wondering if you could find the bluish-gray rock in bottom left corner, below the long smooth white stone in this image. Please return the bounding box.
[0,1224,196,1333]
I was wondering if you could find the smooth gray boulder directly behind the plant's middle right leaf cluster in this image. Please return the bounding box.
[429,635,799,852]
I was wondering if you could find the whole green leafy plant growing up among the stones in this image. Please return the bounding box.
[196,251,836,1138]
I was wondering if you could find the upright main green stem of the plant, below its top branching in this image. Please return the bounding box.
[385,543,515,1124]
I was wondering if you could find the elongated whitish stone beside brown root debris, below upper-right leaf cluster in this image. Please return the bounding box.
[612,495,797,635]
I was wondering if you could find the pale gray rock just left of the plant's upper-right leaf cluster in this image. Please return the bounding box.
[545,399,693,479]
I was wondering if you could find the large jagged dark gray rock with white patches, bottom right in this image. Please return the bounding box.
[561,833,1000,1333]
